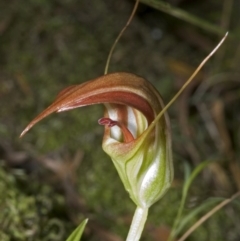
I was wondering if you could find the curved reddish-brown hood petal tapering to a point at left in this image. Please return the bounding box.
[20,72,162,136]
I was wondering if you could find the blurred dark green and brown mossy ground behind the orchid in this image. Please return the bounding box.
[0,0,240,241]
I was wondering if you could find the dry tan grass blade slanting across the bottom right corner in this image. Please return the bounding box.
[178,192,240,241]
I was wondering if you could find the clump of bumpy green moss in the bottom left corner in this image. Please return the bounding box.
[0,164,72,241]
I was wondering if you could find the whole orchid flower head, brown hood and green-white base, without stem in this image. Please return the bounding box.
[21,73,173,208]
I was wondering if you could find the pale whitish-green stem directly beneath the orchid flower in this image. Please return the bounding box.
[126,207,148,241]
